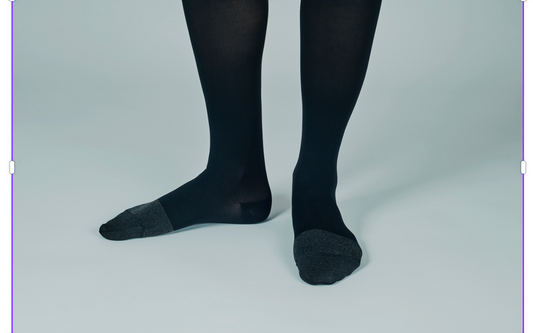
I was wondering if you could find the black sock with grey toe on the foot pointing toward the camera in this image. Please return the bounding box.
[292,0,381,284]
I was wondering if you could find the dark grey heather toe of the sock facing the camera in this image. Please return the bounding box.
[294,229,363,285]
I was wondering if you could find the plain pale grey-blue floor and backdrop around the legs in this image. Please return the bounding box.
[14,0,522,333]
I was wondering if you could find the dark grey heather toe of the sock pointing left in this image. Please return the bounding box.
[99,200,174,240]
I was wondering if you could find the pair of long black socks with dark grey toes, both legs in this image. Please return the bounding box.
[100,0,381,284]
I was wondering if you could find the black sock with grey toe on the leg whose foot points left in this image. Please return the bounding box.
[100,0,271,240]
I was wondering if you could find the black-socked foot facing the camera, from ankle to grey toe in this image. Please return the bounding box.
[292,172,363,285]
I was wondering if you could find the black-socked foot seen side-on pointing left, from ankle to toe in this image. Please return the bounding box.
[99,170,272,240]
